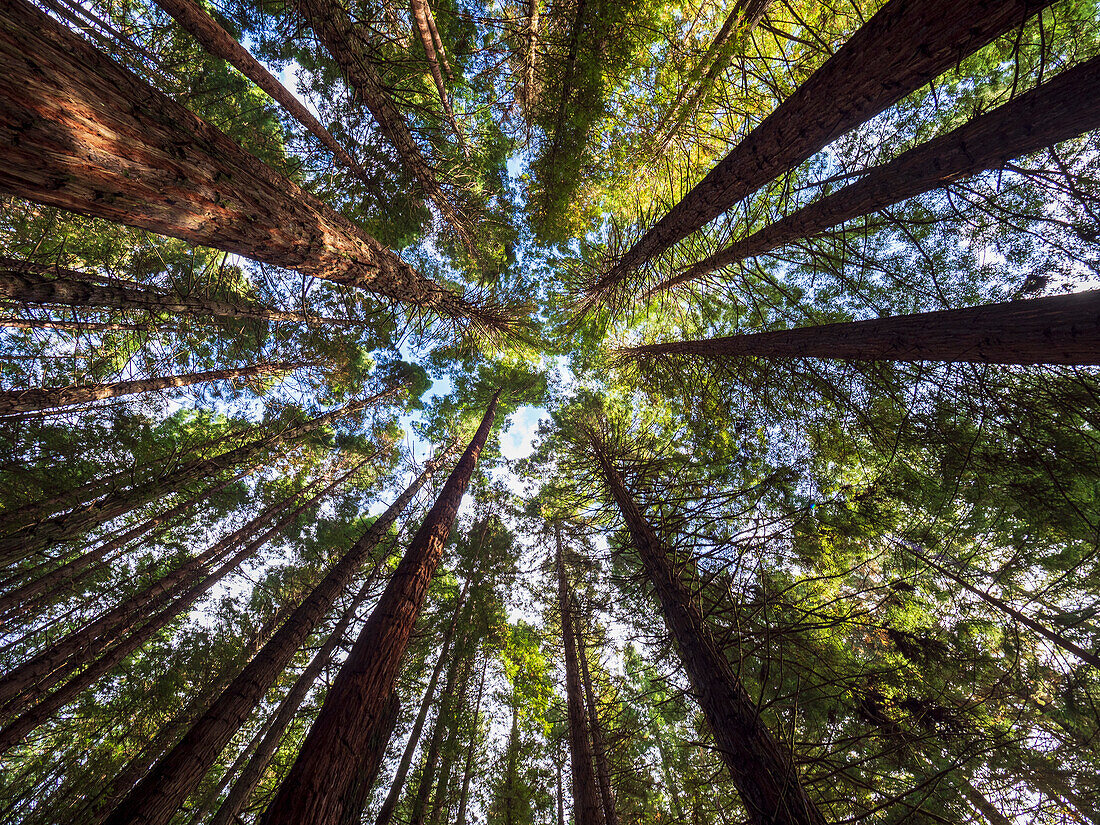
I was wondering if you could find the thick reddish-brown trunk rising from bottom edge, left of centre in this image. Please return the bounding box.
[263,392,499,825]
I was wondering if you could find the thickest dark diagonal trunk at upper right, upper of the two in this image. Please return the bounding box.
[595,0,1051,290]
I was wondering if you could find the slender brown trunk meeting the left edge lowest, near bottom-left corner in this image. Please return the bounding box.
[0,466,352,754]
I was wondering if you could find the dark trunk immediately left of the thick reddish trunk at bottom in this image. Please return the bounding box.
[100,451,449,825]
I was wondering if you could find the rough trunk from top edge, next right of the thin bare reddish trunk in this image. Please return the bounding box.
[294,0,476,260]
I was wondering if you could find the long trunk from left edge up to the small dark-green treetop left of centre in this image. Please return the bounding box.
[0,391,393,563]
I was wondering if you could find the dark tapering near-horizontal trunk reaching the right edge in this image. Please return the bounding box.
[624,289,1100,366]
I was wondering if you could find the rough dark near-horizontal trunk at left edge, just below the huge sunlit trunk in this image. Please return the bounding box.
[0,265,365,327]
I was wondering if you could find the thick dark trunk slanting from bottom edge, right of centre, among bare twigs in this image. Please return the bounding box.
[592,436,825,825]
